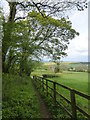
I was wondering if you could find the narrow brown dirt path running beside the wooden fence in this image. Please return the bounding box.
[32,82,52,120]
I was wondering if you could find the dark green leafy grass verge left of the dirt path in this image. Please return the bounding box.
[2,74,40,120]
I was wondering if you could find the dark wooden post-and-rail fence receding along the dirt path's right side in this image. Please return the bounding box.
[33,76,90,120]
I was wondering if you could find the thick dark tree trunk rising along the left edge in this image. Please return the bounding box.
[2,2,16,73]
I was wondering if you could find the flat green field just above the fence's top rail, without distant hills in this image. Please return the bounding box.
[32,70,88,94]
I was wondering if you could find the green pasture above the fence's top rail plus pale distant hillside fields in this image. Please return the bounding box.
[31,62,90,94]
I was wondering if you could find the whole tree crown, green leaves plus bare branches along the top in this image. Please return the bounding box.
[2,0,87,75]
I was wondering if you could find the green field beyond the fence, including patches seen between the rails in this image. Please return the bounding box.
[32,70,88,116]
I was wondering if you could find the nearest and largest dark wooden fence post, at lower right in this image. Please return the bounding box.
[70,90,77,120]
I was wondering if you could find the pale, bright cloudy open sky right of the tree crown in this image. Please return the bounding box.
[0,0,88,62]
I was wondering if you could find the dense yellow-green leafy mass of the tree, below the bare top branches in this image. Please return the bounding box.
[2,11,78,75]
